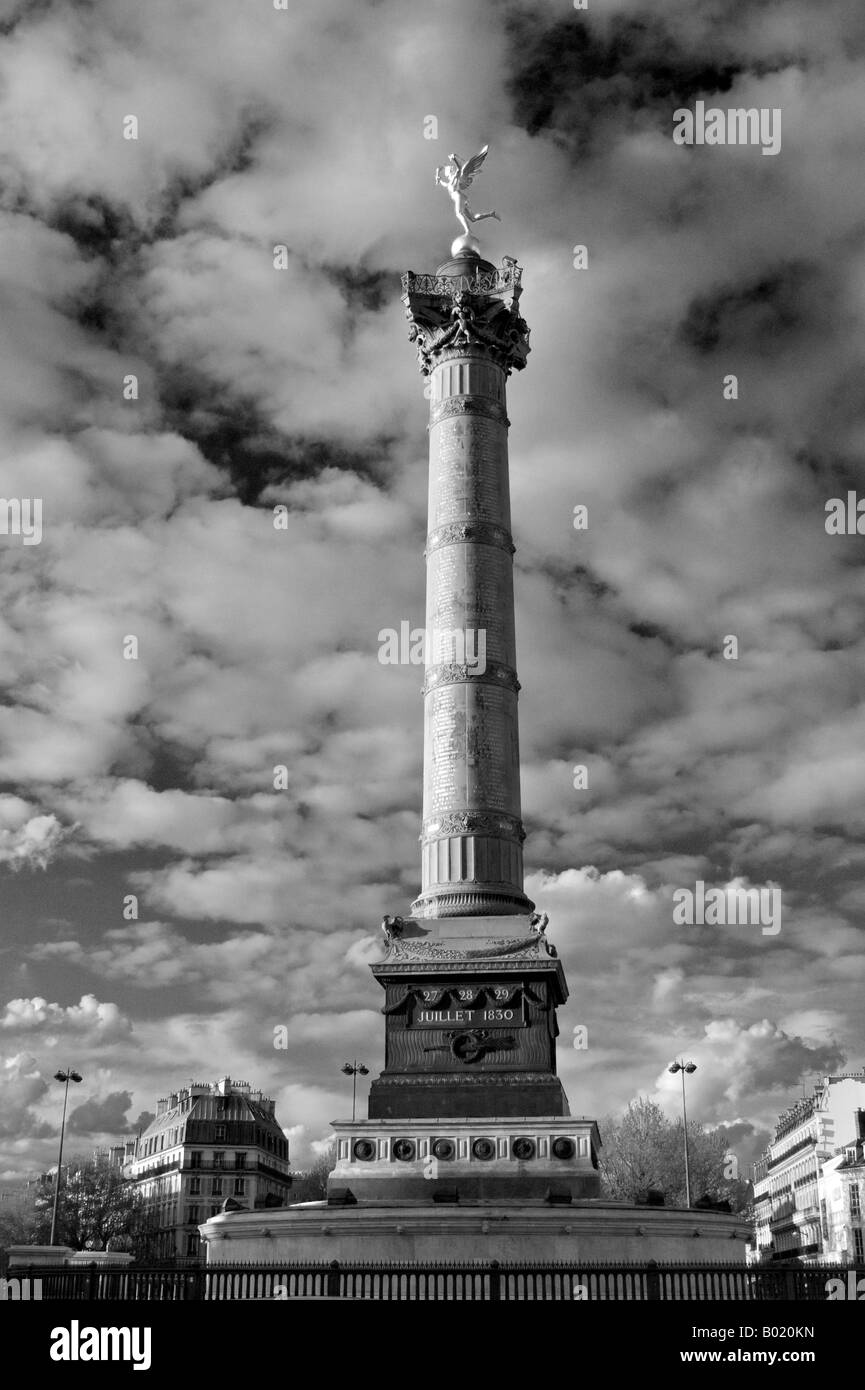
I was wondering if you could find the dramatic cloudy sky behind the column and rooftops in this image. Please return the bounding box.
[0,0,865,1182]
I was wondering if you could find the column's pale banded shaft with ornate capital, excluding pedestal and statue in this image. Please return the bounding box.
[403,253,534,917]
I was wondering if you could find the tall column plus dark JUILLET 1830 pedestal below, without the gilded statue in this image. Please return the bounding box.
[367,239,575,1123]
